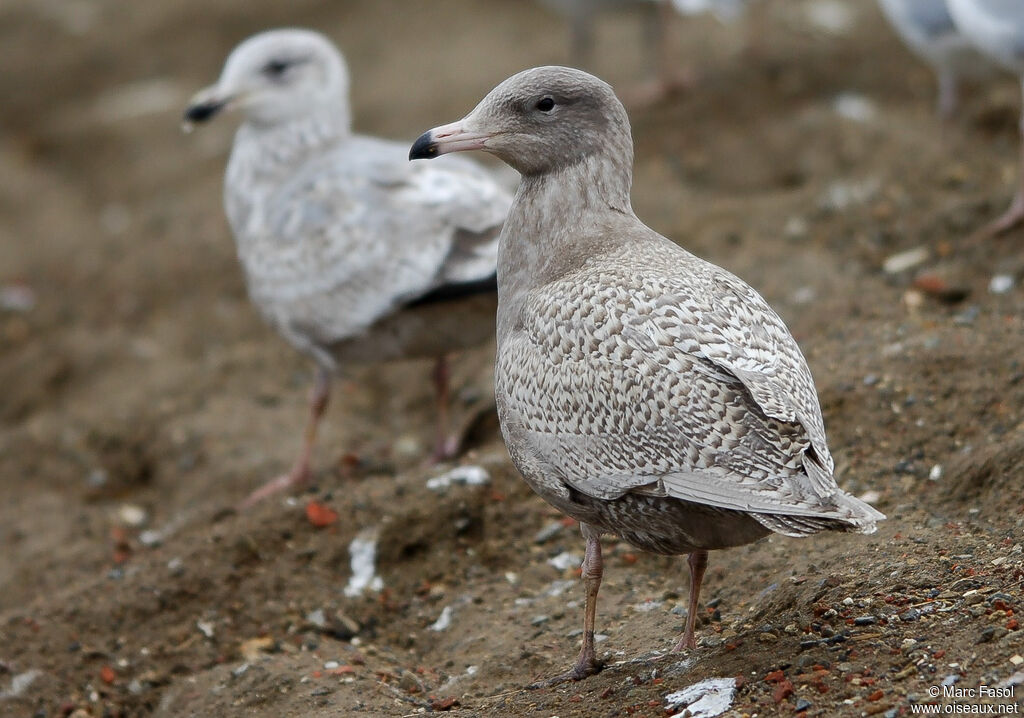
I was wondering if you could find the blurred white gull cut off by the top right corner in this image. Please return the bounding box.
[947,0,1024,236]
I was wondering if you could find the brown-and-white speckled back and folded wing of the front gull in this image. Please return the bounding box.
[496,233,881,533]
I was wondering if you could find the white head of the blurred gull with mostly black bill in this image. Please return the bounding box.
[183,29,348,130]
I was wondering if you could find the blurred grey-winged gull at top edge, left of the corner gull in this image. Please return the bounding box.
[879,0,991,118]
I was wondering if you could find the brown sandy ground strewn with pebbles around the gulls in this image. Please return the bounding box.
[0,0,1024,718]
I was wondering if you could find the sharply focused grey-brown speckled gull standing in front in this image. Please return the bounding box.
[410,68,884,682]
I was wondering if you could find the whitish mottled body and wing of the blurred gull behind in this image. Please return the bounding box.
[227,137,511,363]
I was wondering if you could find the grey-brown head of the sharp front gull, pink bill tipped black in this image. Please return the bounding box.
[409,67,633,177]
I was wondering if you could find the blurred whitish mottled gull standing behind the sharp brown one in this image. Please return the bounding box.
[185,30,511,503]
